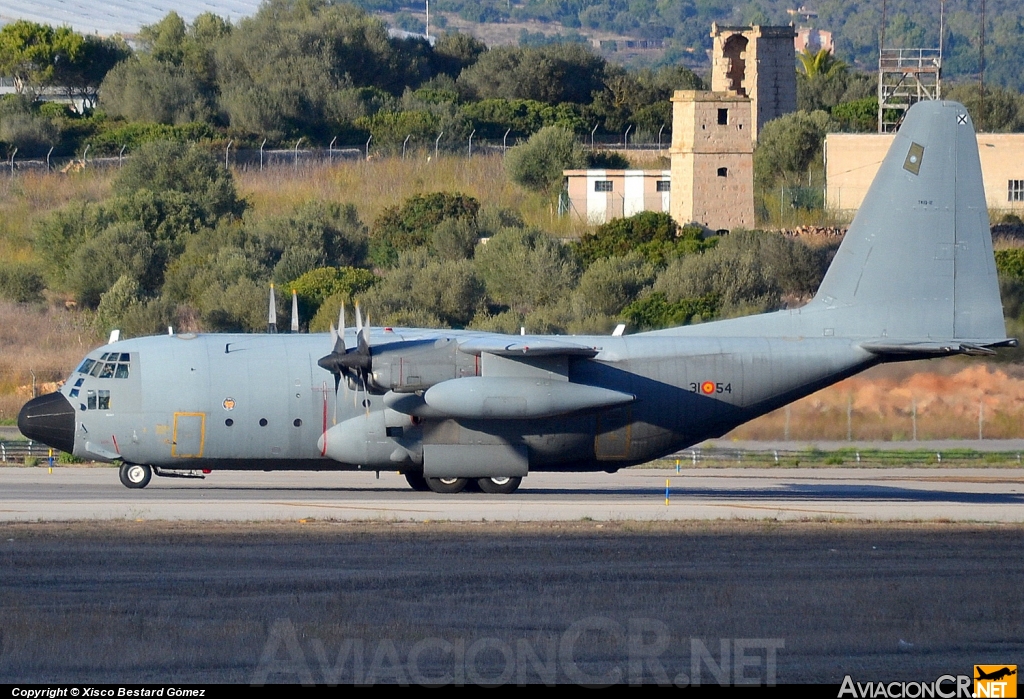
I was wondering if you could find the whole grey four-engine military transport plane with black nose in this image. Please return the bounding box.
[18,101,1016,493]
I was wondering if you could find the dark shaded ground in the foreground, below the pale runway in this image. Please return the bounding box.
[0,521,1024,685]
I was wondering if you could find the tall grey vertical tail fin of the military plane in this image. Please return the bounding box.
[807,101,1006,345]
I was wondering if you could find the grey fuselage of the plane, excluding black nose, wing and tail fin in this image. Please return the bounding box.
[46,331,877,470]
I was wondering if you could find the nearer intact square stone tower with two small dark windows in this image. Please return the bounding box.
[669,90,754,230]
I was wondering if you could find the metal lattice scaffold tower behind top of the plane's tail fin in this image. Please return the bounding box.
[879,48,942,133]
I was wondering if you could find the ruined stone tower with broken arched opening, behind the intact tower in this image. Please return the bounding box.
[711,24,797,140]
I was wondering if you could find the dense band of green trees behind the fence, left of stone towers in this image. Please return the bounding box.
[0,0,700,157]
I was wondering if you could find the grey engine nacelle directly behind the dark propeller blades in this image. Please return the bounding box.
[370,338,478,393]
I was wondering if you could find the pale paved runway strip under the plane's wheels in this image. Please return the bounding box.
[0,467,1024,522]
